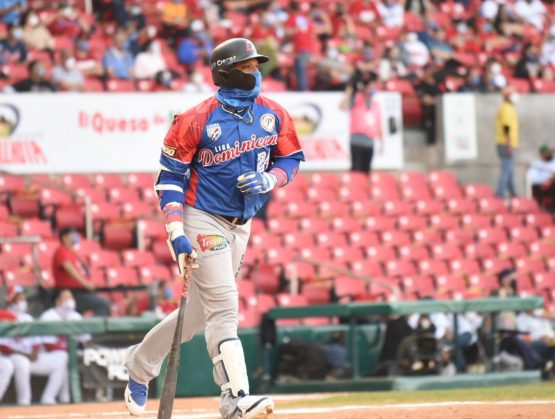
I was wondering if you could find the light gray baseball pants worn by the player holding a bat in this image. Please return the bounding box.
[125,206,251,419]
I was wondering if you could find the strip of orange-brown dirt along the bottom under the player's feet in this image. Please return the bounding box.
[0,395,555,419]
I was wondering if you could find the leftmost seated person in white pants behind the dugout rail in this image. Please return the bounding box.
[0,286,68,405]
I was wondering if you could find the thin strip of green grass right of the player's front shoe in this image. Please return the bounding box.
[280,382,555,407]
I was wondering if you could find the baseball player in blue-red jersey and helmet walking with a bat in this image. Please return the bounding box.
[125,38,304,419]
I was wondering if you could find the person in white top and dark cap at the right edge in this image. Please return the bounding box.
[526,144,555,212]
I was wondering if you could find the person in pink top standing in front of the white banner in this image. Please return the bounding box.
[339,73,383,173]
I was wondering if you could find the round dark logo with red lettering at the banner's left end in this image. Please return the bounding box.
[0,103,48,165]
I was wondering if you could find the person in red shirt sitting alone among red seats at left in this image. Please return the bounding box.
[52,227,110,316]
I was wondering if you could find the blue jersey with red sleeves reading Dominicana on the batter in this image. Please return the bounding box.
[156,96,304,218]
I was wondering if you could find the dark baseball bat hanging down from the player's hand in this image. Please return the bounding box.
[158,280,188,419]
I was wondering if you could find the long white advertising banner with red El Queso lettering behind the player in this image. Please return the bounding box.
[0,92,402,174]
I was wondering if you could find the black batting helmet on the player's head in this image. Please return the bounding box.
[210,38,269,90]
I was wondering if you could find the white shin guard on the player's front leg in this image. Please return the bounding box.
[212,339,249,397]
